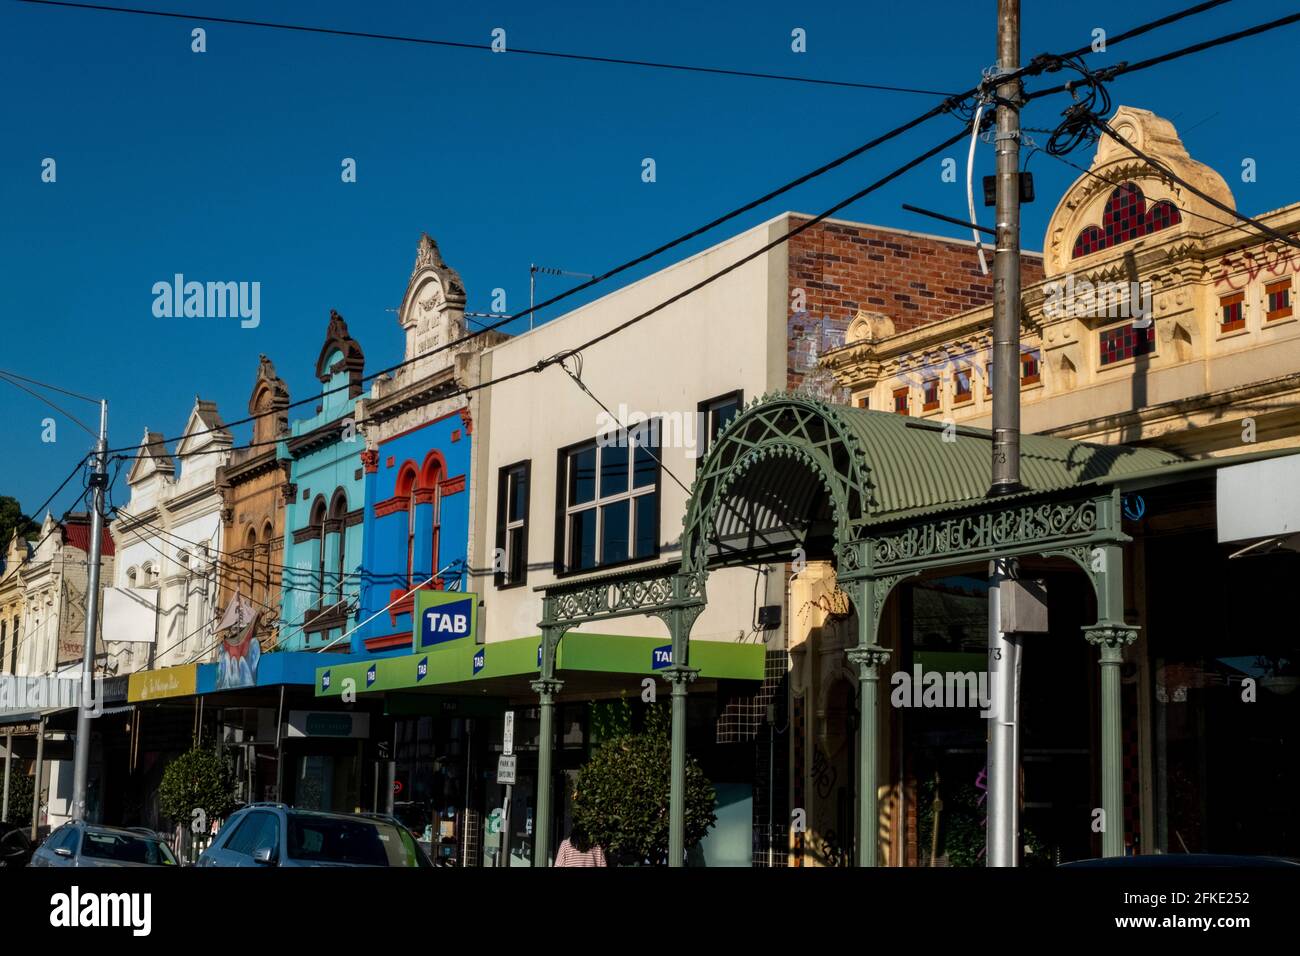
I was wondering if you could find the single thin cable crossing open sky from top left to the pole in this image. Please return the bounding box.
[20,0,952,96]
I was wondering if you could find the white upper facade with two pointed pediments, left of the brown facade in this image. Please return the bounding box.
[104,398,233,676]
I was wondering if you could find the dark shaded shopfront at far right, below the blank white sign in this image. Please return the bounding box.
[1149,532,1300,857]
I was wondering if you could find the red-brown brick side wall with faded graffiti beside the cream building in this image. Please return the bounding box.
[787,216,1043,392]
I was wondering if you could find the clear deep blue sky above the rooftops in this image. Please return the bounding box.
[0,0,1300,514]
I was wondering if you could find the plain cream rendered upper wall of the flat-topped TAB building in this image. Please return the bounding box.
[473,215,789,649]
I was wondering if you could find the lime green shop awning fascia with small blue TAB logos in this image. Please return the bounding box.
[316,632,767,697]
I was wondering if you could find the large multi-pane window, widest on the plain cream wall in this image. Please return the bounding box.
[556,429,659,572]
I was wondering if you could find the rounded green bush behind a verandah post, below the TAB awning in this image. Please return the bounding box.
[573,702,718,864]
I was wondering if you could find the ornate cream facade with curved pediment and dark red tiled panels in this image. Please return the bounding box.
[822,107,1300,457]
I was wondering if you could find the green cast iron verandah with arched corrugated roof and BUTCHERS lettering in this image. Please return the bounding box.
[532,393,1188,866]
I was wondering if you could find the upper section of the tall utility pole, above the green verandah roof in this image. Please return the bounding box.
[989,0,1021,494]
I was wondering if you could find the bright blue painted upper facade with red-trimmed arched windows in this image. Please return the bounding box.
[354,408,473,654]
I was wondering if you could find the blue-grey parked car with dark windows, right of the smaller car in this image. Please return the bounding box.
[195,804,433,868]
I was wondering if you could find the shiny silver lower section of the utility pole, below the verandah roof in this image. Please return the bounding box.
[985,561,1021,866]
